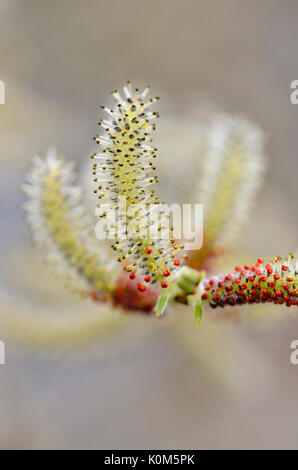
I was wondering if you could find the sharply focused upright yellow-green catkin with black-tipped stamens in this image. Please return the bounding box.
[91,82,181,290]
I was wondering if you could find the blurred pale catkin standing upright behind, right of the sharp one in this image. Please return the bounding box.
[191,114,265,267]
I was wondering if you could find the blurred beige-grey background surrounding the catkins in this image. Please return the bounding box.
[0,0,298,449]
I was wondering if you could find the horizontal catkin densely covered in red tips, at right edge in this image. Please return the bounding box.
[199,253,298,308]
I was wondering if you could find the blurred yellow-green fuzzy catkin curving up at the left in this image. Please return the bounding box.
[23,149,114,293]
